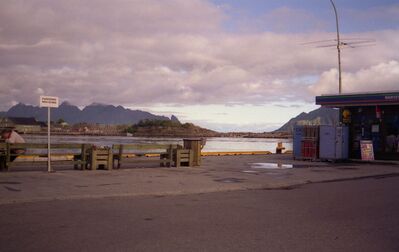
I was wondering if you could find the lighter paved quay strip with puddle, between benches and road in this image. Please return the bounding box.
[0,155,399,205]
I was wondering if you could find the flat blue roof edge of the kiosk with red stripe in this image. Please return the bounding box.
[316,91,399,107]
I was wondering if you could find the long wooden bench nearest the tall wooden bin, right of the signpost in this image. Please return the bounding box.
[112,144,181,168]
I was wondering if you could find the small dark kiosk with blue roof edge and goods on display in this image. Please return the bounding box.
[316,92,399,160]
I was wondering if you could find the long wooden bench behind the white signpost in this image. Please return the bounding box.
[0,143,91,171]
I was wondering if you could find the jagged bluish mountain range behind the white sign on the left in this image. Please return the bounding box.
[5,102,178,124]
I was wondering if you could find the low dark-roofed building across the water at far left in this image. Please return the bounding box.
[0,117,43,133]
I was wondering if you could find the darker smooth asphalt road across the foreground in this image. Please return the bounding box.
[0,175,399,251]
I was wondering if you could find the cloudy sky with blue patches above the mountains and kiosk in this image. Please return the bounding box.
[0,0,399,131]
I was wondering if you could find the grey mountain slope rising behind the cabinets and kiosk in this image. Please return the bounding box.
[276,107,339,132]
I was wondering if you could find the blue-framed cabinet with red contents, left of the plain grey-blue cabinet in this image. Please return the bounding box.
[294,125,320,160]
